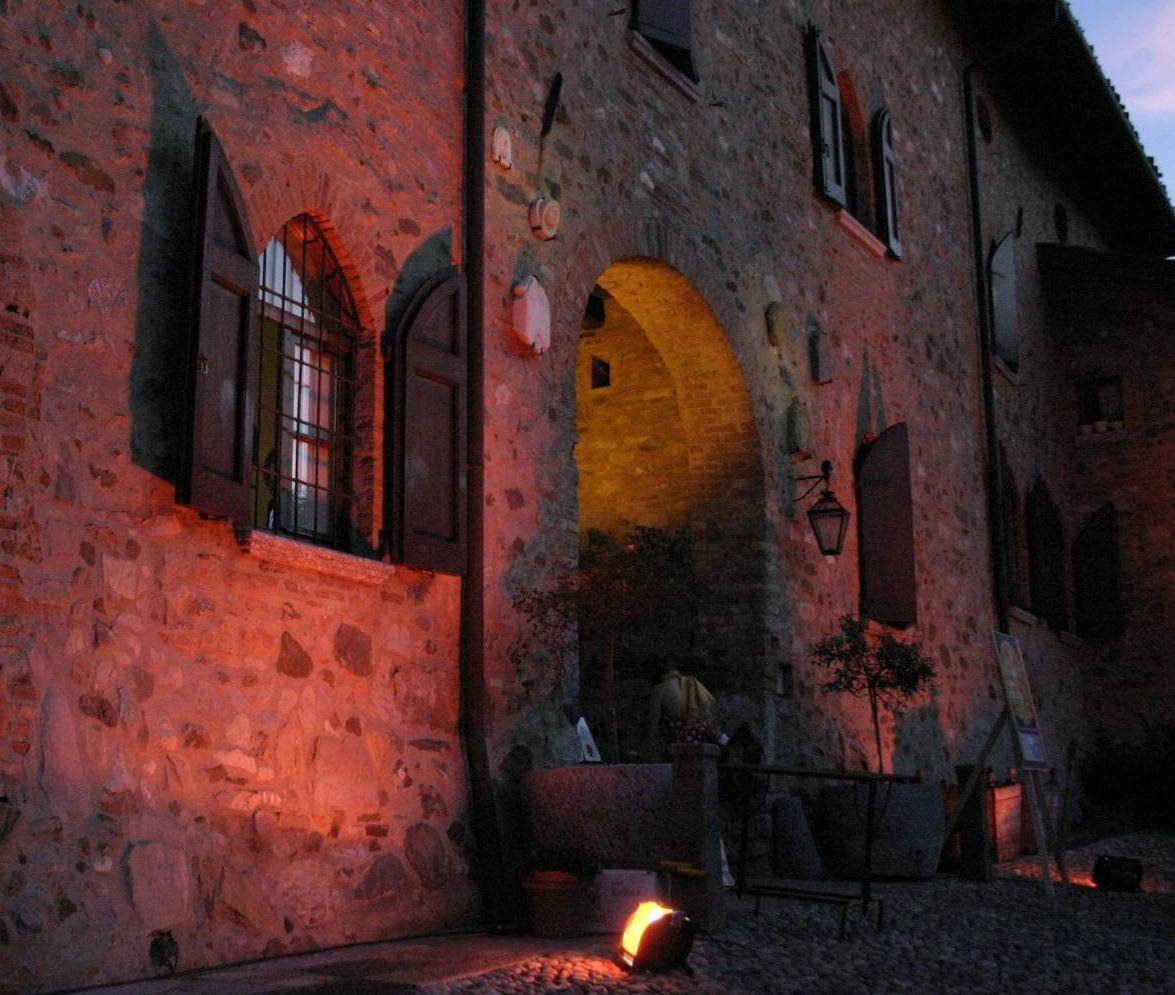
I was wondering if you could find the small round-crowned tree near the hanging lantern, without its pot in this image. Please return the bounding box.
[812,616,934,772]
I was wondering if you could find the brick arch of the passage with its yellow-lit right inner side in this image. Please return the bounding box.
[555,221,767,698]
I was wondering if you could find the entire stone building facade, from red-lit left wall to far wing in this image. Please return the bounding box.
[0,0,1175,990]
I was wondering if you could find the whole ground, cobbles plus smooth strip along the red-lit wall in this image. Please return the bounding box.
[82,834,1175,995]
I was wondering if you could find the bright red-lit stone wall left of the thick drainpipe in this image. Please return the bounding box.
[0,0,476,991]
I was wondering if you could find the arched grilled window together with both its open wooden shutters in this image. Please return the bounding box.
[179,121,468,573]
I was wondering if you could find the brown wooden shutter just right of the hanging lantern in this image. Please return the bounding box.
[857,422,918,625]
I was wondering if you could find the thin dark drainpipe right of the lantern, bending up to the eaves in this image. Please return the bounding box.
[962,2,1061,632]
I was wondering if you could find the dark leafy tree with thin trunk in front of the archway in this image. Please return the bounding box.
[513,525,701,757]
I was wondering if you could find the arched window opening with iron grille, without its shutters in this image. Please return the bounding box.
[251,215,360,546]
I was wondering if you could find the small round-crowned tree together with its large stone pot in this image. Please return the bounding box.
[813,616,944,878]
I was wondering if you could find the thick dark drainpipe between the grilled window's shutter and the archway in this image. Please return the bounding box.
[461,0,504,926]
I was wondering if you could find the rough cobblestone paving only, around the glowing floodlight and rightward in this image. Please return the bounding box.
[424,836,1175,995]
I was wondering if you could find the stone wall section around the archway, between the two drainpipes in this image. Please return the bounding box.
[486,2,1015,774]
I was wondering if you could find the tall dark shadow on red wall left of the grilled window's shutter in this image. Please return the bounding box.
[129,22,200,484]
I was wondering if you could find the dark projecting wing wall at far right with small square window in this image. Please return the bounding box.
[1049,253,1175,761]
